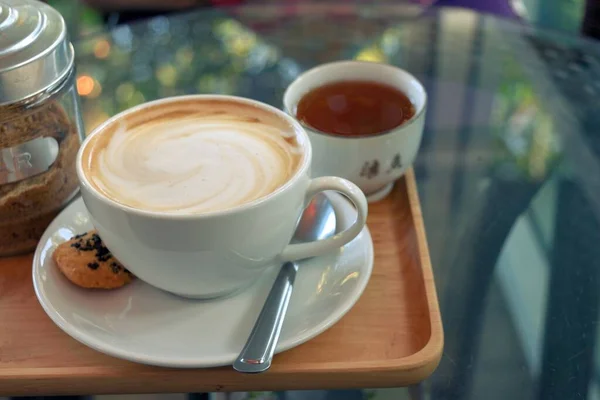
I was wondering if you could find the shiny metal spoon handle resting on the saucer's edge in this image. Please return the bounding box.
[233,262,298,374]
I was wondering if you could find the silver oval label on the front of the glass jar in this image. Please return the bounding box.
[0,137,59,185]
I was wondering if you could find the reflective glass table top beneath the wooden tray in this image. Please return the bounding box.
[76,3,600,400]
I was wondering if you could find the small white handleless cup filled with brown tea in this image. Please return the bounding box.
[283,61,427,201]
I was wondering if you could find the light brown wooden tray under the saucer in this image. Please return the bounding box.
[0,171,443,396]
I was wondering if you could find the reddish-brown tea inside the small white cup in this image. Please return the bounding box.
[296,81,415,136]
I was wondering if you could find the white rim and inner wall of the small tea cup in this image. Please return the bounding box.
[283,60,427,140]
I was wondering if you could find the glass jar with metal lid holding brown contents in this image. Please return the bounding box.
[0,0,84,256]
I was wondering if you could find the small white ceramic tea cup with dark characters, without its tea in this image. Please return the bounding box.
[283,61,427,201]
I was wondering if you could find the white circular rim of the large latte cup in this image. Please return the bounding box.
[75,94,312,220]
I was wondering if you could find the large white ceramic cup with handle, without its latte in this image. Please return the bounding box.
[77,95,367,298]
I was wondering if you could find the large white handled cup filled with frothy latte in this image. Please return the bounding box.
[77,95,367,298]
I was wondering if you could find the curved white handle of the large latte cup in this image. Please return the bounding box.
[279,176,368,261]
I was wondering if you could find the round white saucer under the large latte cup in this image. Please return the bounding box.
[33,193,373,367]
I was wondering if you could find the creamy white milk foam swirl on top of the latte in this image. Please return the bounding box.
[83,103,301,213]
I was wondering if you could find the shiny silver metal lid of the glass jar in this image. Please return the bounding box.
[0,0,74,105]
